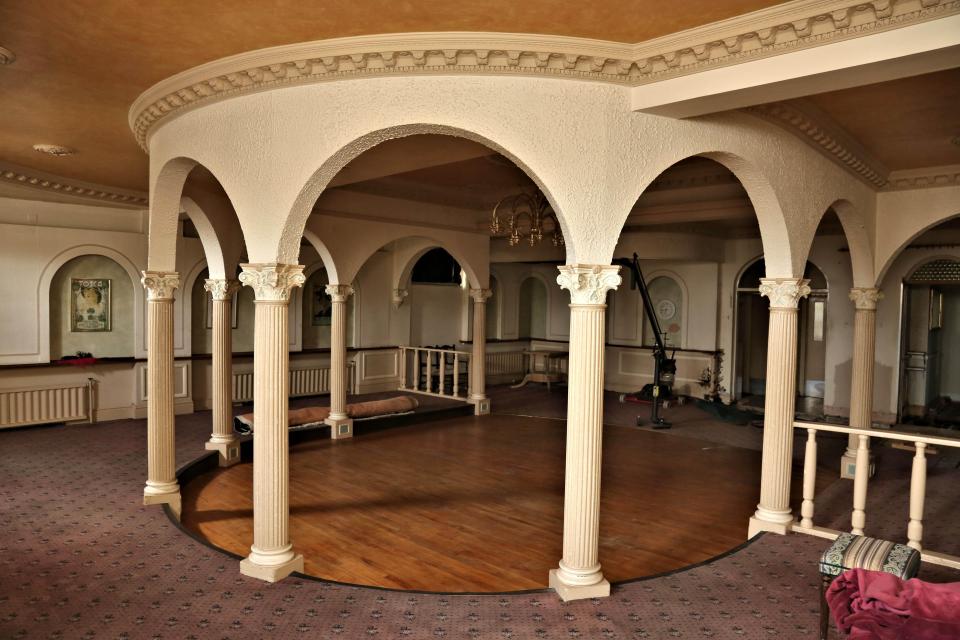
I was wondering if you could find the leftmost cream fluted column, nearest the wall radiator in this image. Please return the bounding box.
[141,271,180,518]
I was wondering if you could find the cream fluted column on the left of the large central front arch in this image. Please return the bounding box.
[240,264,304,582]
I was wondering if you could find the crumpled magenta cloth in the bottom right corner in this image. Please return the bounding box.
[827,569,960,640]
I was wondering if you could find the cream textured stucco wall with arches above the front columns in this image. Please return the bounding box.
[150,73,876,277]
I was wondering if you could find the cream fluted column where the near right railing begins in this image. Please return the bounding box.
[749,278,810,537]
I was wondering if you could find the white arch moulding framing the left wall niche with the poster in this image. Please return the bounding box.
[37,244,147,362]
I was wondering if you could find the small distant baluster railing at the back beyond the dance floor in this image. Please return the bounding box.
[400,347,470,401]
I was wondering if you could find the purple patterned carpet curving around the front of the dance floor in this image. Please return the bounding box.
[0,388,956,640]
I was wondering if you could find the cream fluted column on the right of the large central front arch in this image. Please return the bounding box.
[550,264,620,600]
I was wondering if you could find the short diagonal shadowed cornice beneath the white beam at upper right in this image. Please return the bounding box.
[746,100,890,189]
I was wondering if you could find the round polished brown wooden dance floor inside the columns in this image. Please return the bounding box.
[183,415,760,592]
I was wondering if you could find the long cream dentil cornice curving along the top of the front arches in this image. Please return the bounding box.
[129,0,960,150]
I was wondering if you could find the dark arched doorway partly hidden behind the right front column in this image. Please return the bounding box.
[733,257,828,415]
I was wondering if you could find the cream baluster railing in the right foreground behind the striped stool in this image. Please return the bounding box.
[792,422,960,569]
